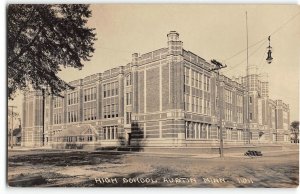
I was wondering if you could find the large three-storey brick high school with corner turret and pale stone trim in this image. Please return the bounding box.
[22,31,289,148]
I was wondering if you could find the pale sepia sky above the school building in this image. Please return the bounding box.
[9,4,300,121]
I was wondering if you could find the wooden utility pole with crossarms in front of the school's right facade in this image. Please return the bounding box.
[210,59,227,158]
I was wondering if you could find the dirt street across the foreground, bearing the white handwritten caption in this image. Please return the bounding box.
[8,148,299,187]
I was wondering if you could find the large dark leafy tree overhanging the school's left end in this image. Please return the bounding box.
[7,4,96,99]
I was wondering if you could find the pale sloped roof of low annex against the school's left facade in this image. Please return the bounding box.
[54,124,97,137]
